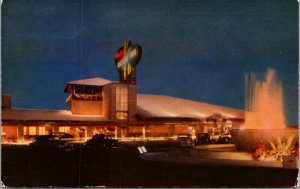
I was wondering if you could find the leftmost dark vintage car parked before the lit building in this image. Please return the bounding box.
[29,135,74,152]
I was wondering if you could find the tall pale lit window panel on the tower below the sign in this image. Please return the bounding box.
[116,86,128,119]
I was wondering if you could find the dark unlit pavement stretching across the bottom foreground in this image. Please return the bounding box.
[1,142,298,187]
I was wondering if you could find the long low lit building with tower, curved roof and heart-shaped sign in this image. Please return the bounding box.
[2,42,244,142]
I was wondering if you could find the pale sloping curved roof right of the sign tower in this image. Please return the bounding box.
[137,94,244,119]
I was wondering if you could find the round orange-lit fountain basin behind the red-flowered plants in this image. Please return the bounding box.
[231,128,298,152]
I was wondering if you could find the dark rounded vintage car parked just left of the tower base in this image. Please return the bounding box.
[84,134,119,150]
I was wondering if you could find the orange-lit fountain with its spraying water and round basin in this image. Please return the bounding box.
[231,69,298,152]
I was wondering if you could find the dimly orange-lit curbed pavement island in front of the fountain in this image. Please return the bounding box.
[141,144,286,168]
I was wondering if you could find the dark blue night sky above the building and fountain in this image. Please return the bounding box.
[2,0,298,124]
